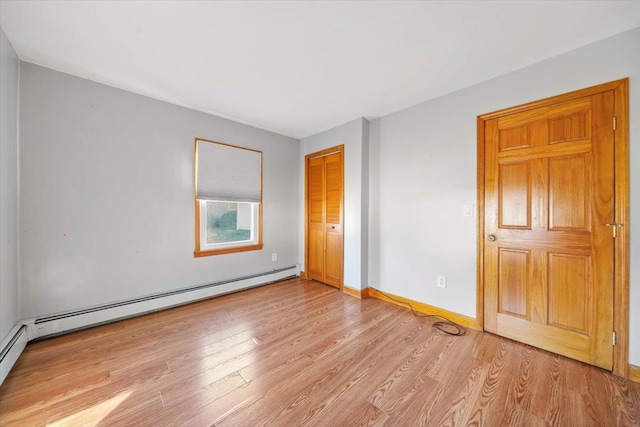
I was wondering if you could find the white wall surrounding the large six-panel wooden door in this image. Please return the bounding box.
[369,29,640,365]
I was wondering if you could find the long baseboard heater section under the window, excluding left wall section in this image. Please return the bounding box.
[33,266,300,339]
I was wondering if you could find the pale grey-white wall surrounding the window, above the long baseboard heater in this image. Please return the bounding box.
[20,62,299,318]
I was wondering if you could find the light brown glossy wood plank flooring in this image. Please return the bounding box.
[0,279,640,427]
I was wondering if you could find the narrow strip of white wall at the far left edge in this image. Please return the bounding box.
[0,28,20,342]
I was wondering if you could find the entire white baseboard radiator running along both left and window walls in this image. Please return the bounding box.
[0,265,300,384]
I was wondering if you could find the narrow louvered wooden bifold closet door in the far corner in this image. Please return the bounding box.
[306,146,343,288]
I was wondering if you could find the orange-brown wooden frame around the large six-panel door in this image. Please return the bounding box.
[476,78,630,378]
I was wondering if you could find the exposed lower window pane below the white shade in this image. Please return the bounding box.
[205,200,253,245]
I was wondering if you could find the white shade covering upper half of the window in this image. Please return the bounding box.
[196,140,262,203]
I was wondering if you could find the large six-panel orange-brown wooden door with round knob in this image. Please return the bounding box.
[483,90,615,370]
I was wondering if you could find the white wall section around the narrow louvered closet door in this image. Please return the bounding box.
[298,118,369,289]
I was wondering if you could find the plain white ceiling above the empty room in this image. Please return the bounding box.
[0,0,640,138]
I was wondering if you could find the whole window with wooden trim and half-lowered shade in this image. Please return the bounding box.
[194,139,262,257]
